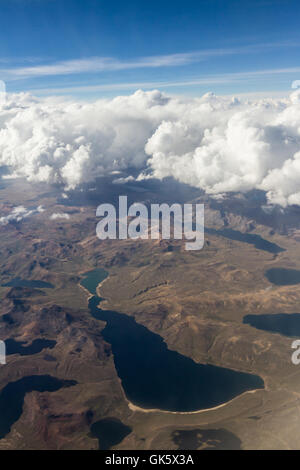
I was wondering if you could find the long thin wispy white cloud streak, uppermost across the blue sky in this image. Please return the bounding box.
[0,42,299,80]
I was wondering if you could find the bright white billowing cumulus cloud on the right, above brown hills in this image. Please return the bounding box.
[145,91,300,206]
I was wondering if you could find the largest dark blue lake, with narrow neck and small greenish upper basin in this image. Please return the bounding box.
[82,269,264,412]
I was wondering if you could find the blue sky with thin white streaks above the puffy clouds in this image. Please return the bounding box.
[0,0,300,99]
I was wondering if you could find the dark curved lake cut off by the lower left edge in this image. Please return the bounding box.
[0,375,77,439]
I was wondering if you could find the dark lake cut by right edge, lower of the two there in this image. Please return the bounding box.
[243,313,300,338]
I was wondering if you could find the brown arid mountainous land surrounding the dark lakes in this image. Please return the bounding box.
[0,180,300,449]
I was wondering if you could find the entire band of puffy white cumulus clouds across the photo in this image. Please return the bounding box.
[0,91,300,206]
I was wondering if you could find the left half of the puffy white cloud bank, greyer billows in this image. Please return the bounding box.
[0,92,171,188]
